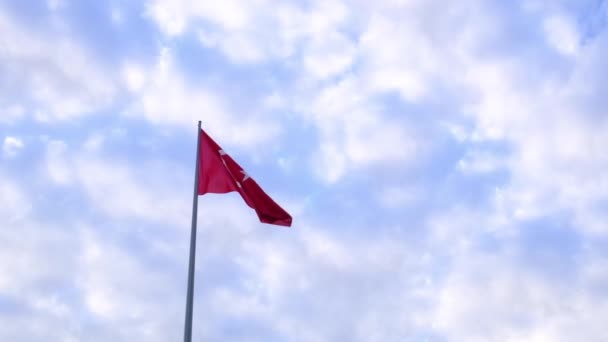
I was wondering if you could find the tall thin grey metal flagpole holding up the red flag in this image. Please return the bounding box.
[184,121,201,342]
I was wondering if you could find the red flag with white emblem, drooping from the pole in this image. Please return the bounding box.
[198,130,291,227]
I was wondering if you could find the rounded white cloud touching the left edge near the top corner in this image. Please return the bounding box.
[0,7,116,121]
